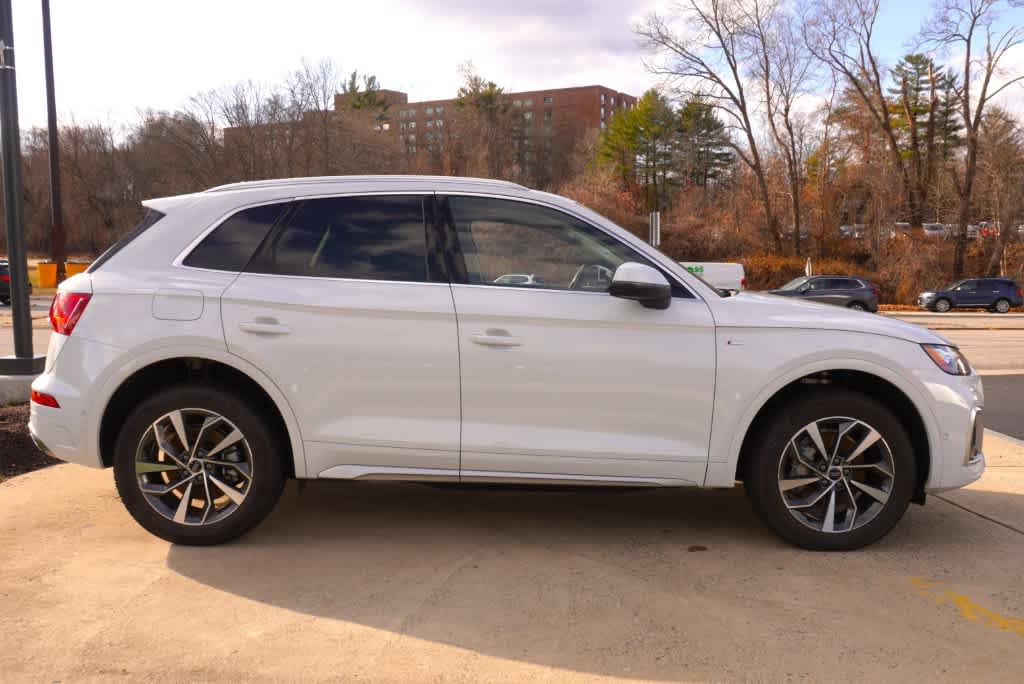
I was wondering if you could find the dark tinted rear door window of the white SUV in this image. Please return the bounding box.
[247,197,427,282]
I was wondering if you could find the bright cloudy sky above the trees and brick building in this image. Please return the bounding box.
[13,0,1024,128]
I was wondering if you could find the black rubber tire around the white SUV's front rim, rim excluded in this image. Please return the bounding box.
[743,388,916,551]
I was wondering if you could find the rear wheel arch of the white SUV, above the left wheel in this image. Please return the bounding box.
[96,350,306,477]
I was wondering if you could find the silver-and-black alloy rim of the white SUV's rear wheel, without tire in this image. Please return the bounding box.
[135,409,253,525]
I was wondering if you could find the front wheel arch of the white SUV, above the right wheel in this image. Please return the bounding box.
[733,368,933,503]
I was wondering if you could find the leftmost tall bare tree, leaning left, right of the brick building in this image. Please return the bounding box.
[636,0,782,252]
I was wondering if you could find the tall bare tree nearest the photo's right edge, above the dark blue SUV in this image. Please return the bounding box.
[922,0,1024,277]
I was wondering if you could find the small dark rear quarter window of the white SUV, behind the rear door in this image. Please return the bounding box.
[184,204,288,270]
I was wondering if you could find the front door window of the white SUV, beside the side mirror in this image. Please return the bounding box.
[450,197,639,292]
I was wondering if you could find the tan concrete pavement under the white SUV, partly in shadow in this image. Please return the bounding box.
[0,438,1024,682]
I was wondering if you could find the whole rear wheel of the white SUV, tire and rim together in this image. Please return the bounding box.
[114,386,285,545]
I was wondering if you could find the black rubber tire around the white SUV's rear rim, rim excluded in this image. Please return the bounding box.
[114,384,288,546]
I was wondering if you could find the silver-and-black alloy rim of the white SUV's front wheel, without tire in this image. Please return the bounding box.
[778,416,896,532]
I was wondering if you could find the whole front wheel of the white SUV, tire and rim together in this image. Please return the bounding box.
[744,388,916,551]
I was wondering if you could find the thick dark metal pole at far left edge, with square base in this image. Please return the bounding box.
[0,0,39,373]
